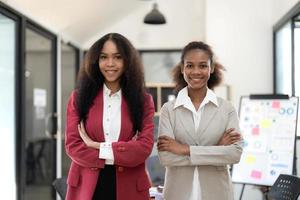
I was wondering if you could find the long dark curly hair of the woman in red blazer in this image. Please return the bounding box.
[76,33,146,131]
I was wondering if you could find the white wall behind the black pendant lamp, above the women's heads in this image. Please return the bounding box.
[83,0,205,49]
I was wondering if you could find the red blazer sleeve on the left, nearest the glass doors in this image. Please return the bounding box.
[65,91,105,168]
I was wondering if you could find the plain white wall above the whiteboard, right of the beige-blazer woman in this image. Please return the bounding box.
[205,0,273,107]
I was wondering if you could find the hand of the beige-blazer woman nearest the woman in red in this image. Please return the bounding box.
[157,135,190,155]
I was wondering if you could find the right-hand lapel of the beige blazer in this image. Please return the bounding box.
[197,102,218,138]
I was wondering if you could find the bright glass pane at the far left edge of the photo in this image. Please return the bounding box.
[0,13,16,200]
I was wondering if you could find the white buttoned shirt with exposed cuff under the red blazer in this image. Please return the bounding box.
[99,84,122,165]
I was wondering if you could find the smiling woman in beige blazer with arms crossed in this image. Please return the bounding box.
[157,42,242,200]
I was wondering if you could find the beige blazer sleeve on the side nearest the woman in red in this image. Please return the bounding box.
[158,103,192,166]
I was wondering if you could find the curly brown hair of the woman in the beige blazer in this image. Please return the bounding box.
[173,41,225,92]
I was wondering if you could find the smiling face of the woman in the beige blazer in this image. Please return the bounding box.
[181,49,213,90]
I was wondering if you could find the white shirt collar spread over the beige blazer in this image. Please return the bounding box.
[174,87,219,109]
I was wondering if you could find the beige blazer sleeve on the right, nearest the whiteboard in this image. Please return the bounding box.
[190,103,243,166]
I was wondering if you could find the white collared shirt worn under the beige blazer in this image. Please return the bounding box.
[174,87,219,200]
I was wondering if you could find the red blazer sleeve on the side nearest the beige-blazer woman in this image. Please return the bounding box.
[112,94,154,167]
